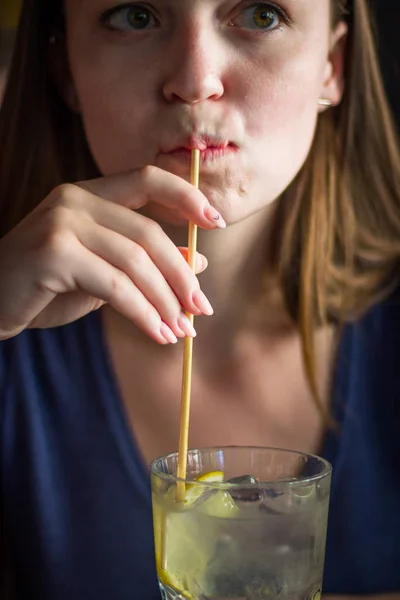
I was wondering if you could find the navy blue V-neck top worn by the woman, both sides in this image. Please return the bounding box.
[0,294,400,600]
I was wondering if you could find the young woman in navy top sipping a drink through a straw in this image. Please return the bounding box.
[0,0,400,600]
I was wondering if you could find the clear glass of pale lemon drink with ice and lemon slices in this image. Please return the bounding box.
[152,448,330,600]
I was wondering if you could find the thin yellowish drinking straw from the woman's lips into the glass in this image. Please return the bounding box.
[176,150,200,502]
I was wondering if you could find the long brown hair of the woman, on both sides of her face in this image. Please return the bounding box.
[0,0,400,412]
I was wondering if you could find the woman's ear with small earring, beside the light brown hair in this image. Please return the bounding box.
[320,21,348,111]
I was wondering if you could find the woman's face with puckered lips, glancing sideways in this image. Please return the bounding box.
[66,0,345,223]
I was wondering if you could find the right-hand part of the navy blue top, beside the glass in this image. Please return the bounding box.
[324,290,400,594]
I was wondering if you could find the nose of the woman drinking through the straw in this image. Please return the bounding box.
[163,28,224,104]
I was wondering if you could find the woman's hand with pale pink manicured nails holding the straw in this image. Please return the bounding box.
[0,167,225,344]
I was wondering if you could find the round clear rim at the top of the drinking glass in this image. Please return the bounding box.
[150,445,332,490]
